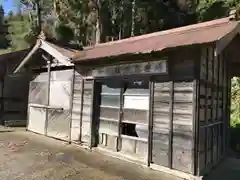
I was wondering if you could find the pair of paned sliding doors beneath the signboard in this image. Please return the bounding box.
[98,78,149,162]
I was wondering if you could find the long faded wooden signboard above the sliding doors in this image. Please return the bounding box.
[87,60,168,77]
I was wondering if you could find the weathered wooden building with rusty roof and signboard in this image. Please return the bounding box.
[15,9,240,179]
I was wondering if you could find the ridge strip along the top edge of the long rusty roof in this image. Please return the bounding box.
[84,17,231,50]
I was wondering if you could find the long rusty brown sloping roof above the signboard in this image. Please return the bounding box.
[72,17,239,62]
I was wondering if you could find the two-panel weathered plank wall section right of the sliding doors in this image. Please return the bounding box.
[152,82,193,172]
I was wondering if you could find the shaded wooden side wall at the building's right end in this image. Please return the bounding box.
[197,46,229,175]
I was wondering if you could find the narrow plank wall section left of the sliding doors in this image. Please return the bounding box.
[71,71,93,146]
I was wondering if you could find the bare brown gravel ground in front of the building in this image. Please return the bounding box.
[0,131,180,180]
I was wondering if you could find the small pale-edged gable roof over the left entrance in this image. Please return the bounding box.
[14,39,78,73]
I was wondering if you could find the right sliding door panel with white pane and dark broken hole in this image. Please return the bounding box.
[120,79,149,161]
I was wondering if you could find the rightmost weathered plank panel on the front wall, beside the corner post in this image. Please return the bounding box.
[172,82,195,173]
